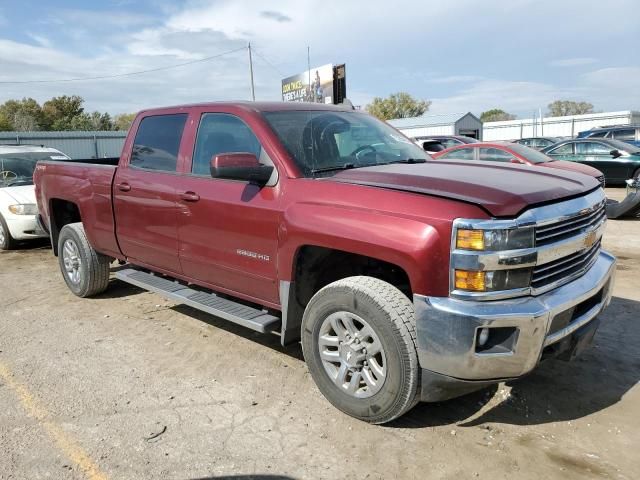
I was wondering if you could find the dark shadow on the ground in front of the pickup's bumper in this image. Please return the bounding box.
[390,297,640,428]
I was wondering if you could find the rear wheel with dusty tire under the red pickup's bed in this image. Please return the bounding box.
[58,223,111,298]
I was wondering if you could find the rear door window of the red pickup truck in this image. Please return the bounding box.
[129,113,187,172]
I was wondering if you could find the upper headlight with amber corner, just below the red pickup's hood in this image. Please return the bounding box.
[456,227,534,251]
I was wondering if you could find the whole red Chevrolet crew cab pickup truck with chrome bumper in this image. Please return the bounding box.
[35,102,615,423]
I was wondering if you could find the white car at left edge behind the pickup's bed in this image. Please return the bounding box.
[0,145,71,250]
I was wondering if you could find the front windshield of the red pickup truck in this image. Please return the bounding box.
[263,110,430,176]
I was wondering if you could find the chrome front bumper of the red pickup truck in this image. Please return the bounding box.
[414,251,616,397]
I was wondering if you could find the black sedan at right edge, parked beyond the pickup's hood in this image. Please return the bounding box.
[542,138,640,184]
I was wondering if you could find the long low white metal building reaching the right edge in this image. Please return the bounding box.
[482,110,640,141]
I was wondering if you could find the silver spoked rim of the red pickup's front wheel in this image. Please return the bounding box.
[318,311,387,398]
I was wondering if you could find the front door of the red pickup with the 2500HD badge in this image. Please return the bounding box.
[177,112,280,304]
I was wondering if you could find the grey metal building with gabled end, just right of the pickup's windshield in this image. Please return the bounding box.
[387,112,482,139]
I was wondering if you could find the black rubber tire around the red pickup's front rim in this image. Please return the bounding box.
[301,276,420,424]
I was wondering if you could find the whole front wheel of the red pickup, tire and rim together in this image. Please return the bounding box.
[302,276,420,424]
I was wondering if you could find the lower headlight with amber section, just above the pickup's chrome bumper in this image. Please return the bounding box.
[455,268,531,292]
